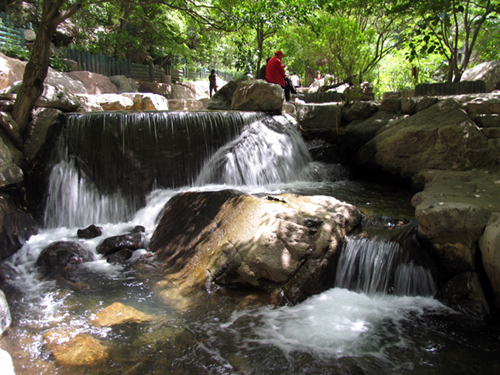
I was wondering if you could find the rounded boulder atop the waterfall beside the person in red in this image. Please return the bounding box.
[231,79,285,112]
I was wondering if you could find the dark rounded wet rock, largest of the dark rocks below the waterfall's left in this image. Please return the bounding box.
[36,241,94,277]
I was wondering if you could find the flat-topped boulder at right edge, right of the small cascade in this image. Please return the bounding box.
[412,168,500,290]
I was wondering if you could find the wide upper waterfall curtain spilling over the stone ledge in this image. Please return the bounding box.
[44,112,316,228]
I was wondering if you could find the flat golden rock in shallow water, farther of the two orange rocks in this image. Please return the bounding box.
[90,302,154,327]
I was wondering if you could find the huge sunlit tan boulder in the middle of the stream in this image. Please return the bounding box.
[149,190,361,303]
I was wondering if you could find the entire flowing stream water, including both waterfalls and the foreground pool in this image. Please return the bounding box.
[2,112,500,375]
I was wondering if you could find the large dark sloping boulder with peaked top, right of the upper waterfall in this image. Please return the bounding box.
[357,99,495,178]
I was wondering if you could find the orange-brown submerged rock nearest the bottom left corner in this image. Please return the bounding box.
[44,330,109,367]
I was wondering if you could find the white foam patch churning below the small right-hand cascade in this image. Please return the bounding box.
[220,288,452,361]
